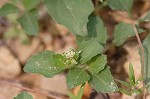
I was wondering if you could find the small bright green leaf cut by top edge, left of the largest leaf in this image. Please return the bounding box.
[23,0,41,11]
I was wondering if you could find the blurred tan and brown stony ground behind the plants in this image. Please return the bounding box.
[0,0,150,99]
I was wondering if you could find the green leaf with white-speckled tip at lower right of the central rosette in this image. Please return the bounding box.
[90,67,118,93]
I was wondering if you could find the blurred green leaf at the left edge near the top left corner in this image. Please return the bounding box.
[0,3,19,16]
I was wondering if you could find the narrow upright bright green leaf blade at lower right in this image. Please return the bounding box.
[129,63,135,86]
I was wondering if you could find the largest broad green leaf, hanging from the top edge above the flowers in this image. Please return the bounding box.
[44,0,94,36]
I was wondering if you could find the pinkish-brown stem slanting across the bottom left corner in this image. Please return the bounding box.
[0,80,67,99]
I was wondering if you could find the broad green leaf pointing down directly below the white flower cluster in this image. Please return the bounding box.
[67,68,90,89]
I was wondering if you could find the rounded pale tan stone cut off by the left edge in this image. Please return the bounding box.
[0,46,21,79]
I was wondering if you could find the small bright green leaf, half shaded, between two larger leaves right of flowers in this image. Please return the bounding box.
[87,55,107,73]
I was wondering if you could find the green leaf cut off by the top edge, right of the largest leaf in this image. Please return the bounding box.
[108,0,133,12]
